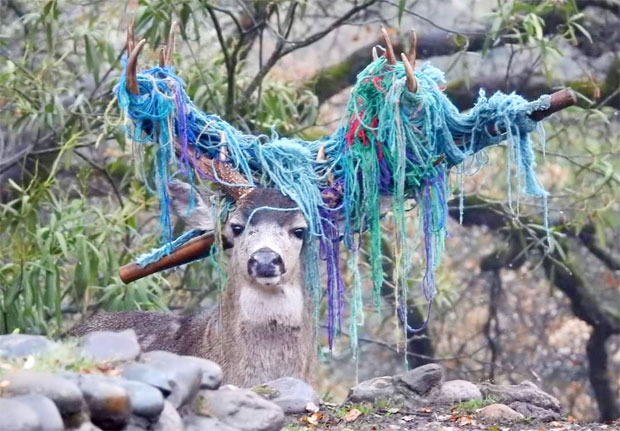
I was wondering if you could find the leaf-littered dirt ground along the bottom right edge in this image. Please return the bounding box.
[284,404,620,431]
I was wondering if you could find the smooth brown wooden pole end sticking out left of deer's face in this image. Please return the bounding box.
[118,232,215,284]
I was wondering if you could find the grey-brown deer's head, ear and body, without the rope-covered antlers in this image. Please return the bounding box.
[72,182,317,387]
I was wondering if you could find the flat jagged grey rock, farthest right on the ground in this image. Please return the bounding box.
[478,381,560,412]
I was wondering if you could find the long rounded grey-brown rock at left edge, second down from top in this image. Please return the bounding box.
[3,371,84,417]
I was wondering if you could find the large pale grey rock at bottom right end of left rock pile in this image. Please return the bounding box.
[194,385,284,431]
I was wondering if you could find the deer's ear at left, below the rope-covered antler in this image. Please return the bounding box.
[168,180,215,230]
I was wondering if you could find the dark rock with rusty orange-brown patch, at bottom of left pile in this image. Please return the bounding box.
[79,374,131,430]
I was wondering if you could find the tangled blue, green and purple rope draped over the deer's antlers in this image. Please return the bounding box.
[115,24,575,347]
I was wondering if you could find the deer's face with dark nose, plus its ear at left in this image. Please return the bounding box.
[170,181,307,290]
